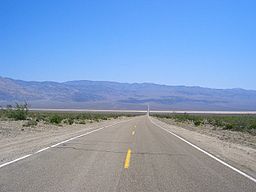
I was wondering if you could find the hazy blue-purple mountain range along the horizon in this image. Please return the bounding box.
[0,77,256,111]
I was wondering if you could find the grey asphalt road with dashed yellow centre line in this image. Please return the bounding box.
[0,116,256,192]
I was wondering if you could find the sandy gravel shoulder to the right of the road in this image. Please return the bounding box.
[152,118,256,178]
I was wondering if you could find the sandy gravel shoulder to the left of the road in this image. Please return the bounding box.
[0,117,129,164]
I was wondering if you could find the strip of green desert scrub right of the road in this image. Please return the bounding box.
[153,113,256,135]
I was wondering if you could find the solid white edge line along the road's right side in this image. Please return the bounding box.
[149,118,256,183]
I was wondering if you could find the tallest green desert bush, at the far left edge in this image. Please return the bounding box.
[5,103,28,121]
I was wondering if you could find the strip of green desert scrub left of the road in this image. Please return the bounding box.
[0,103,137,127]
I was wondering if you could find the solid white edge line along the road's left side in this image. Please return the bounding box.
[0,119,132,168]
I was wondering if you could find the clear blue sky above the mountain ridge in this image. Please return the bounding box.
[0,0,256,89]
